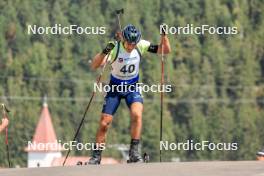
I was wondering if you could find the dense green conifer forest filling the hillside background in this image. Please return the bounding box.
[0,0,264,167]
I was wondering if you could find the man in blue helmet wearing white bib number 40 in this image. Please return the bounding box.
[88,24,171,164]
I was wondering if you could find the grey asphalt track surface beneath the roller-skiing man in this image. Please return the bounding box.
[0,161,264,176]
